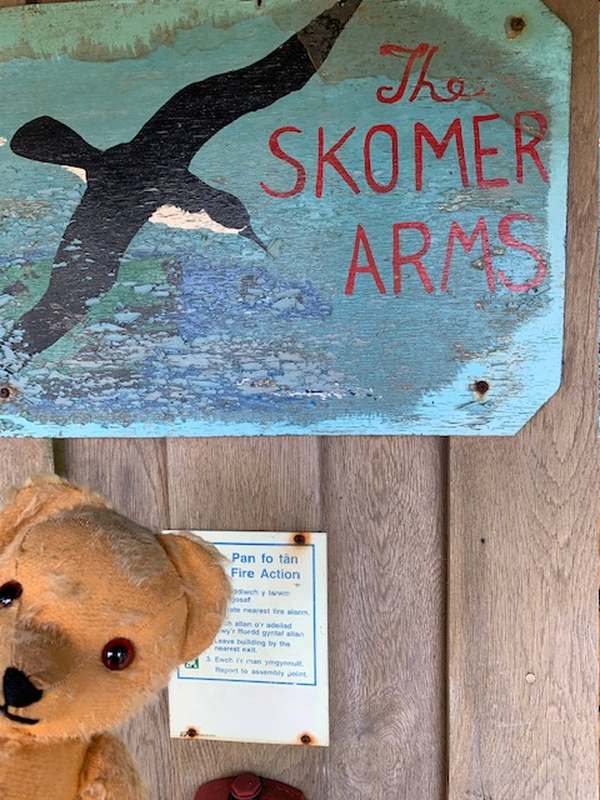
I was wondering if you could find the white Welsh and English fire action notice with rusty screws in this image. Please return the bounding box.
[169,531,329,745]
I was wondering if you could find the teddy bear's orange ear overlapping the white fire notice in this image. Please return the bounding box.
[157,533,231,663]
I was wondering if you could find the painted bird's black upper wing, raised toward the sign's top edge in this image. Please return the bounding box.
[132,0,362,166]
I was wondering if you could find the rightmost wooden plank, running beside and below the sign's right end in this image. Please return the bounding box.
[448,0,599,800]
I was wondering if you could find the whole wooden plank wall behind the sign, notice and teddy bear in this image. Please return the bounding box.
[0,0,600,800]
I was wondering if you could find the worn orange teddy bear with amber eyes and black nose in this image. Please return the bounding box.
[0,476,230,800]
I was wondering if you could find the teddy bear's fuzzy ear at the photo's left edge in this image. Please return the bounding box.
[0,475,107,549]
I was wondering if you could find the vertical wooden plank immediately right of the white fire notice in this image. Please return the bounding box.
[324,438,446,800]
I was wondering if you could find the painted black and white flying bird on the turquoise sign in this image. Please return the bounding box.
[10,0,362,361]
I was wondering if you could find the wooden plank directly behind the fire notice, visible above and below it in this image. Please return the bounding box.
[167,438,327,800]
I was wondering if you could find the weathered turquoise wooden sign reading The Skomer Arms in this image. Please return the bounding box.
[0,0,571,436]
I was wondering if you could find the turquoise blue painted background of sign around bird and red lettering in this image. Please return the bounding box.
[0,0,571,436]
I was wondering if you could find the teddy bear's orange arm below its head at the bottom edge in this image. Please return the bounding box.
[76,735,147,800]
